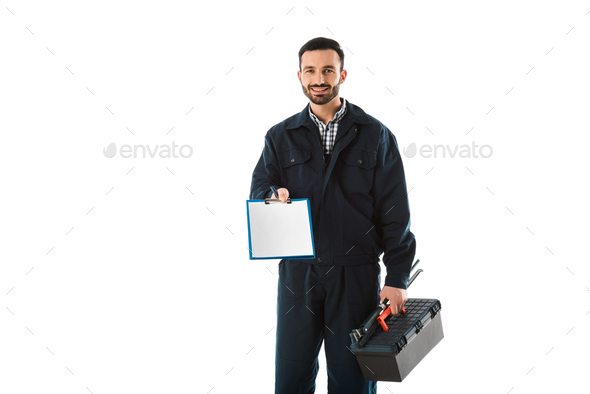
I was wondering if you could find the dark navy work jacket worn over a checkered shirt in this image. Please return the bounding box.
[250,102,416,289]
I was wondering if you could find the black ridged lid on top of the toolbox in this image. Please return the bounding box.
[351,298,441,353]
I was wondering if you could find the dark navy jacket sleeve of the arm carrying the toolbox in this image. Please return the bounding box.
[373,126,416,289]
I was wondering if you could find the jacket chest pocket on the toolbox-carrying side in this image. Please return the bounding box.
[338,149,377,197]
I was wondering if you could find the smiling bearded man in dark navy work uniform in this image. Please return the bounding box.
[250,37,416,394]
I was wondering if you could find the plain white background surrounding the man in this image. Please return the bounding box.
[0,1,590,394]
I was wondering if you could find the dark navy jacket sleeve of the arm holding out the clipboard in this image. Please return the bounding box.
[250,131,282,200]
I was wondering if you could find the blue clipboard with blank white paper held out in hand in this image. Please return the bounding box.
[246,198,315,260]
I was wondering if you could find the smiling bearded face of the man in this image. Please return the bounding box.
[297,49,346,105]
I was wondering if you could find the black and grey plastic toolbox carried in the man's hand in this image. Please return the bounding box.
[350,262,444,382]
